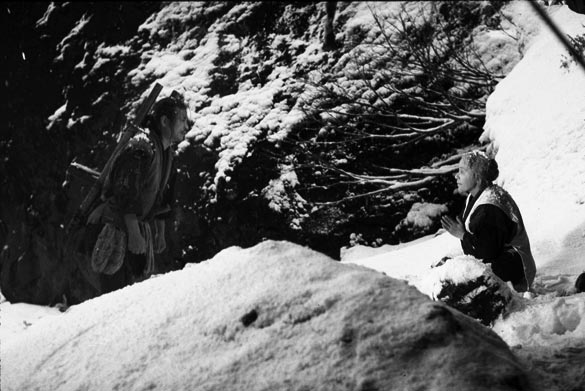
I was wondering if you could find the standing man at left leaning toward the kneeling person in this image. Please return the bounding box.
[88,94,188,293]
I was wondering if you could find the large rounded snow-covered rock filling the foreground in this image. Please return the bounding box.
[1,241,528,390]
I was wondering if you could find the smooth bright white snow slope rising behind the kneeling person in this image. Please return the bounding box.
[484,7,585,274]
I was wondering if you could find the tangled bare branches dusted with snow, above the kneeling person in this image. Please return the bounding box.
[295,2,502,205]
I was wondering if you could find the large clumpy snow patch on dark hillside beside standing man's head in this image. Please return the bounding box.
[129,2,322,201]
